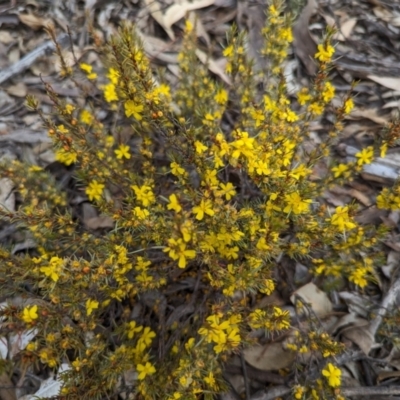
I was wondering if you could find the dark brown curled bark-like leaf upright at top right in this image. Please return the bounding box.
[293,0,317,75]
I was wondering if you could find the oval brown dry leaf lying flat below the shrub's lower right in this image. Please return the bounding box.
[243,343,296,371]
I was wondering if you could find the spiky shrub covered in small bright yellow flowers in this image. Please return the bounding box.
[0,1,400,400]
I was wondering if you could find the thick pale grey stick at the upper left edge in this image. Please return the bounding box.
[0,33,68,84]
